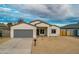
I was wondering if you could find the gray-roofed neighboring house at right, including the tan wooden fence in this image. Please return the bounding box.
[60,23,79,36]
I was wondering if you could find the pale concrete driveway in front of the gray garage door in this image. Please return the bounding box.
[0,38,33,54]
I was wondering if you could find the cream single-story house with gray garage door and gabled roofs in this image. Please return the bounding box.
[10,20,60,38]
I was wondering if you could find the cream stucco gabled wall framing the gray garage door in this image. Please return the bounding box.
[10,23,36,38]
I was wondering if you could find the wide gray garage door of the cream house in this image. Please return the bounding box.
[14,30,33,38]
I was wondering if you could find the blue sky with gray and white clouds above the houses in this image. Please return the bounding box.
[0,4,79,26]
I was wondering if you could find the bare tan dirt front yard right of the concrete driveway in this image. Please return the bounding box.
[32,36,79,54]
